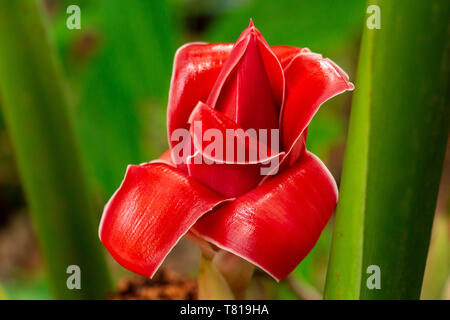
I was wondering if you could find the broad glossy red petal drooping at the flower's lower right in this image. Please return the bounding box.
[191,152,337,280]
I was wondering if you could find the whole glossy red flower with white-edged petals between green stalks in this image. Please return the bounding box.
[100,23,353,280]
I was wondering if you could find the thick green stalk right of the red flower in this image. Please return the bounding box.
[325,0,450,299]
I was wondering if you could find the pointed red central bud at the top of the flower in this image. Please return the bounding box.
[207,24,284,129]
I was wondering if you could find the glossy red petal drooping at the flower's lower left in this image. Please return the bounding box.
[99,163,229,277]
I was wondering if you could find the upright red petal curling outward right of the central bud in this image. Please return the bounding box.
[281,53,354,164]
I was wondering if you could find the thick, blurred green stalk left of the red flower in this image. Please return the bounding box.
[0,0,109,299]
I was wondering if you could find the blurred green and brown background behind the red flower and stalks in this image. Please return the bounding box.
[0,0,450,299]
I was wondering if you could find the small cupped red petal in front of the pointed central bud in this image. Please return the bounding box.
[188,102,283,197]
